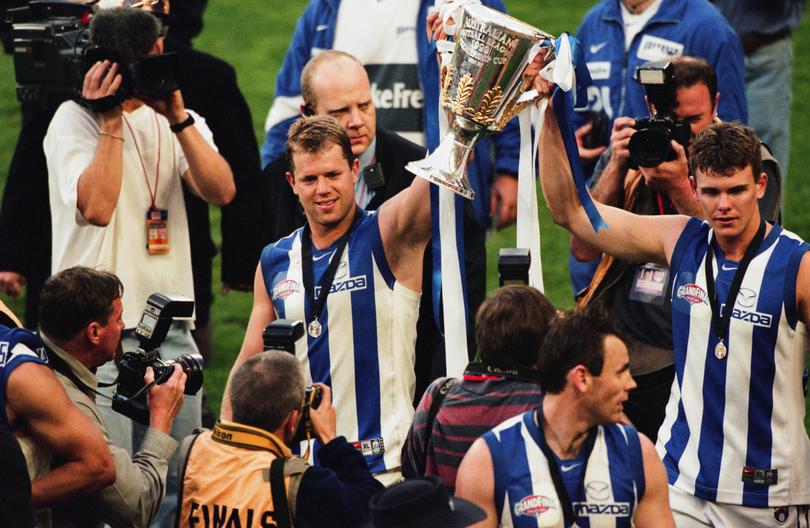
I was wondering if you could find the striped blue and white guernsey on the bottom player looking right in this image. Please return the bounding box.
[483,410,645,528]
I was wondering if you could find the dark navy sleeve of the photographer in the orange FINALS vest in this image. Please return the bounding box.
[295,436,383,527]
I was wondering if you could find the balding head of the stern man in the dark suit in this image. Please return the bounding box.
[301,50,377,156]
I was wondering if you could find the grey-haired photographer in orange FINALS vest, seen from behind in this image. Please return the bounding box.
[176,351,382,527]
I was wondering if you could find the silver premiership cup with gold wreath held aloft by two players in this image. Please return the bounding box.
[407,4,554,200]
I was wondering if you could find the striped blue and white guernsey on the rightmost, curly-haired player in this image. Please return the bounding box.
[657,218,810,507]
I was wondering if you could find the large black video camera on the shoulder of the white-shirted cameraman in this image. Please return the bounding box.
[6,0,178,111]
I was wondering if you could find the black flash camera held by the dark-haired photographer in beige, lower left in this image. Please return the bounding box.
[112,293,203,425]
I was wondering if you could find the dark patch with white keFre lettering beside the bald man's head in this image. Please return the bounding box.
[366,64,424,132]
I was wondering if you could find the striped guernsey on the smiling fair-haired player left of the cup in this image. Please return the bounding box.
[261,212,419,473]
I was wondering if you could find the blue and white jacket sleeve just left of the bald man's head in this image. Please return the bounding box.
[260,0,334,167]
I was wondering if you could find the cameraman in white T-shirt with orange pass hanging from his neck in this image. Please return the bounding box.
[43,8,234,494]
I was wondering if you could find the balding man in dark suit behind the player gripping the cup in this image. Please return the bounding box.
[262,50,485,397]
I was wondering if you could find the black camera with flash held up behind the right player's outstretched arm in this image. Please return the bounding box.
[629,61,692,169]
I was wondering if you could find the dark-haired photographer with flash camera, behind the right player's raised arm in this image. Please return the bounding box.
[571,56,779,441]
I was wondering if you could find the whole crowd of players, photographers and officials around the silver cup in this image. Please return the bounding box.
[0,0,810,528]
